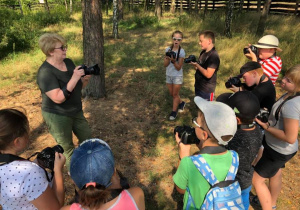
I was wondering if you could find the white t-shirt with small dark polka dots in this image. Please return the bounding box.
[0,160,48,210]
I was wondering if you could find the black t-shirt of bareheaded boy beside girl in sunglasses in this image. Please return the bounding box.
[195,48,220,93]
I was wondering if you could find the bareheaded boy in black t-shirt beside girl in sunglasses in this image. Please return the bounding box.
[190,31,220,101]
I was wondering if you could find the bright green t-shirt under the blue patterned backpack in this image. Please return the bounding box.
[173,151,232,209]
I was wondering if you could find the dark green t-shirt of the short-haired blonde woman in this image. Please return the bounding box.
[37,58,82,116]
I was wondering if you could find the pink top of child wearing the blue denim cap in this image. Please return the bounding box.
[70,190,138,210]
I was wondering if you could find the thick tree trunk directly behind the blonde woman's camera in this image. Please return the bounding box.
[82,0,106,99]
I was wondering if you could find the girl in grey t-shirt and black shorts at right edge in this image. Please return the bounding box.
[252,64,300,209]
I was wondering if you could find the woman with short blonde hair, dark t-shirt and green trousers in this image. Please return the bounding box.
[37,33,91,171]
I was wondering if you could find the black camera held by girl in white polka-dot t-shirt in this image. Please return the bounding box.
[36,145,64,171]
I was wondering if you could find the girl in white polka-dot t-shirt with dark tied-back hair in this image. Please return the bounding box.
[0,109,66,210]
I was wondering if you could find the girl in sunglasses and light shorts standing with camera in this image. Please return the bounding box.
[164,31,185,120]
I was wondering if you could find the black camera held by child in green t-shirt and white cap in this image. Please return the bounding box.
[174,125,200,144]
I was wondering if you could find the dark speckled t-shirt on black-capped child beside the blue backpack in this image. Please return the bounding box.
[226,126,262,190]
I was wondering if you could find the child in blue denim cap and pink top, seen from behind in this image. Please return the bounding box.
[62,139,145,210]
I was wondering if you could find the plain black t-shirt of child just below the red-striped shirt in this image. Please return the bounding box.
[251,79,276,112]
